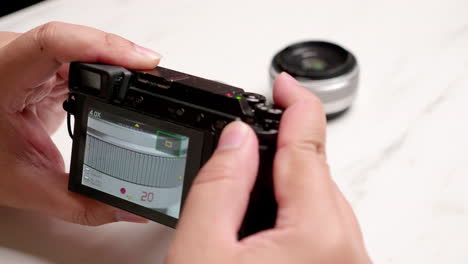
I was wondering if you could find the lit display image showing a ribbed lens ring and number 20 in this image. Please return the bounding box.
[82,109,189,218]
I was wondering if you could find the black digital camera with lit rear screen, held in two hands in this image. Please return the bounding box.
[64,62,283,237]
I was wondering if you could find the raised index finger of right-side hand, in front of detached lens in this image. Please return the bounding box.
[274,73,335,225]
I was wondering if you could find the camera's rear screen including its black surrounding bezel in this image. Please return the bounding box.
[69,95,207,227]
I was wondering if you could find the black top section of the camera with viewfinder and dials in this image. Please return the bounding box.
[69,62,282,134]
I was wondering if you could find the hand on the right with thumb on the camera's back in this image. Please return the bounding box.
[166,73,371,264]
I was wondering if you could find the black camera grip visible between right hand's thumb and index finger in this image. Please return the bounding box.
[239,130,278,239]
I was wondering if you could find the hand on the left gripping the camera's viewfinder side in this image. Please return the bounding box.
[0,22,160,225]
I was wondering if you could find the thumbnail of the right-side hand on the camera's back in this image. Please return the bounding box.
[217,121,249,150]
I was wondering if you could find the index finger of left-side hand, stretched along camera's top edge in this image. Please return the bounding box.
[0,22,160,111]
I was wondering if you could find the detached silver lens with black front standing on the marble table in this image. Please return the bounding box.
[270,41,359,118]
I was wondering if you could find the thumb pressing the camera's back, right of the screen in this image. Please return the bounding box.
[177,121,258,241]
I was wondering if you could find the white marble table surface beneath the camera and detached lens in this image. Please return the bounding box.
[0,0,468,264]
